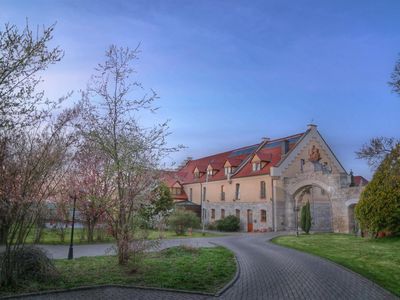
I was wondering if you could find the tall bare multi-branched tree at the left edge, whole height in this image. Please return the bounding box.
[0,24,79,284]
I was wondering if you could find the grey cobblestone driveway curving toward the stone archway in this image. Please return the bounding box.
[7,233,398,300]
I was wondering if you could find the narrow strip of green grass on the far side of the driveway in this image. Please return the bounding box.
[27,228,222,245]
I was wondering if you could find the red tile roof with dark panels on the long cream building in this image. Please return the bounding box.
[166,132,304,186]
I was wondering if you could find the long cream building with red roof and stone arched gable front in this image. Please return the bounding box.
[162,125,368,232]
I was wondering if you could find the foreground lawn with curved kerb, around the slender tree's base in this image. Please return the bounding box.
[0,247,236,296]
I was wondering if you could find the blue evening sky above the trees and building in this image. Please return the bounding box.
[0,0,400,178]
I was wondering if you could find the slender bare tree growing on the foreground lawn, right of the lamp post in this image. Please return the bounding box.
[83,45,177,264]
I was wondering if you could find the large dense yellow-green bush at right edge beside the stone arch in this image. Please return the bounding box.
[355,145,400,236]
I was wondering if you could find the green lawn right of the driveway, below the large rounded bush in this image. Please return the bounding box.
[272,234,400,296]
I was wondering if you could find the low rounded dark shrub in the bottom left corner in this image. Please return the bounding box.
[0,246,58,283]
